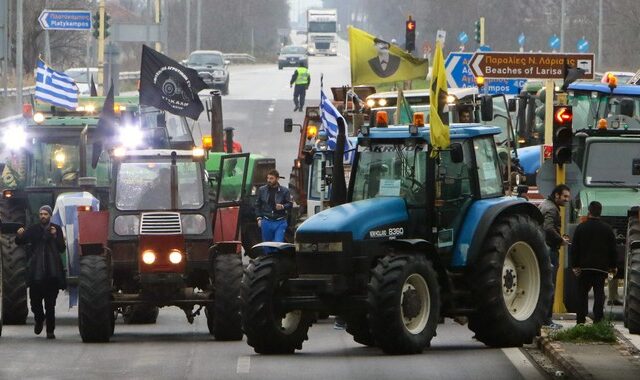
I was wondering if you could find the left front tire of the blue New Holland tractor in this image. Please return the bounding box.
[240,253,315,354]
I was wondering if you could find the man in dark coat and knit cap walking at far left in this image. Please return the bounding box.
[16,205,66,339]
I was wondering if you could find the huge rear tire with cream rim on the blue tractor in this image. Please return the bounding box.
[469,215,553,347]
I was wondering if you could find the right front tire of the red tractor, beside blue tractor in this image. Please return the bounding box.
[206,254,242,340]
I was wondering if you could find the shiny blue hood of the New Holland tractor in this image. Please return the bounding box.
[296,197,409,240]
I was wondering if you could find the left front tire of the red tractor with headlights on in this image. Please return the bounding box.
[78,256,114,343]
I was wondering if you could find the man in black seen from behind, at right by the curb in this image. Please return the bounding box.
[570,201,617,323]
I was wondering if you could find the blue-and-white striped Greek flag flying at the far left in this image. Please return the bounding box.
[36,59,78,110]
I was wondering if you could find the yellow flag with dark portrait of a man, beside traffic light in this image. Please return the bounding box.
[349,27,429,86]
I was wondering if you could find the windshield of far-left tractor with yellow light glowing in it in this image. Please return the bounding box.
[29,139,80,187]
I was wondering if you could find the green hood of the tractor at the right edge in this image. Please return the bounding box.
[578,188,640,218]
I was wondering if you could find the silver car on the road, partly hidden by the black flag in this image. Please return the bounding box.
[185,50,229,95]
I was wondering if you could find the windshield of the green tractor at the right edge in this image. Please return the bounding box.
[584,139,640,188]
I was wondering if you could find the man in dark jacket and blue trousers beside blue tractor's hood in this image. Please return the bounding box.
[255,169,293,242]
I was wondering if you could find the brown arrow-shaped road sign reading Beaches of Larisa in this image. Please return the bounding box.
[469,52,594,79]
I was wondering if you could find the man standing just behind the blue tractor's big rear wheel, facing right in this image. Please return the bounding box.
[539,184,571,329]
